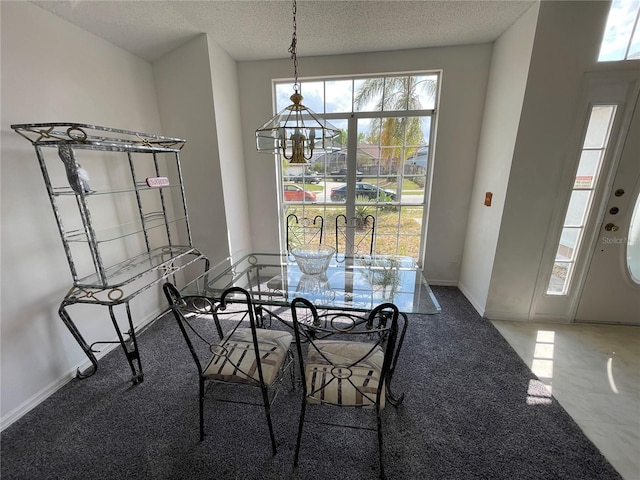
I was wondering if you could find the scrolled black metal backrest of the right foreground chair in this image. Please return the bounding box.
[291,298,399,408]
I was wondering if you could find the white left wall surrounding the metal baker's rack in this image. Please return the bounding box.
[0,2,168,426]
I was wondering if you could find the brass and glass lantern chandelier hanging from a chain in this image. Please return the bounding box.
[256,0,340,164]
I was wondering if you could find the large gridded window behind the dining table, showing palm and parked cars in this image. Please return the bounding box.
[275,72,439,261]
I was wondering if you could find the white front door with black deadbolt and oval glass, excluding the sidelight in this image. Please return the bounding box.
[575,88,640,324]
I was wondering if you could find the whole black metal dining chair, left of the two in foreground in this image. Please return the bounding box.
[163,282,293,455]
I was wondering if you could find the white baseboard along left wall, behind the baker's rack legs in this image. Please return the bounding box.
[0,309,166,432]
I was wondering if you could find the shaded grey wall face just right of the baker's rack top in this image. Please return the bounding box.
[153,35,230,263]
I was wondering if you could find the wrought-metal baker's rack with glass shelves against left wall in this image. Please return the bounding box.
[11,123,209,384]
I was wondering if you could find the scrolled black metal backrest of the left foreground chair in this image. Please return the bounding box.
[163,282,264,384]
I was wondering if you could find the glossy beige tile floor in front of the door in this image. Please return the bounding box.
[492,321,640,480]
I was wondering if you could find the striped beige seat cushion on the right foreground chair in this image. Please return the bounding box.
[305,340,385,408]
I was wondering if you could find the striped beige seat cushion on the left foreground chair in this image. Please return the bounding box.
[204,328,293,385]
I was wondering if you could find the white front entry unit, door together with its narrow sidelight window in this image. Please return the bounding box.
[529,68,640,324]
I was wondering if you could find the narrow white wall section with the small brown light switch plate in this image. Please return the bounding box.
[459,3,539,314]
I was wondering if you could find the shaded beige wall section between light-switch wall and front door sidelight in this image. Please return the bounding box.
[485,1,609,320]
